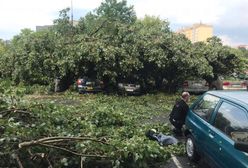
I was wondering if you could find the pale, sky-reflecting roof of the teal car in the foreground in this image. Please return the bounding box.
[207,91,248,108]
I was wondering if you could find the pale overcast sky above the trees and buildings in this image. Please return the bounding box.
[0,0,248,46]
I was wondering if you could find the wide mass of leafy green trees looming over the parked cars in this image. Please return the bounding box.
[0,0,244,91]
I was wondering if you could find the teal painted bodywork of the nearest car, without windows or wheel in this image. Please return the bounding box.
[185,91,248,168]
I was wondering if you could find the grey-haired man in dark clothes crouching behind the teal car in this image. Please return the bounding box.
[169,92,190,136]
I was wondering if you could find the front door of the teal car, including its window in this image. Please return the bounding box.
[206,101,248,168]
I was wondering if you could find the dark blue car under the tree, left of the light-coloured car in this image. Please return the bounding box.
[77,77,104,93]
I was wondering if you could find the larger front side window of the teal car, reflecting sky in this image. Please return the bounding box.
[214,102,248,142]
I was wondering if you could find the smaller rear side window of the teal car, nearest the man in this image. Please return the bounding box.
[193,94,220,121]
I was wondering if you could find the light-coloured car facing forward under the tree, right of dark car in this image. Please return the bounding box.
[118,83,141,95]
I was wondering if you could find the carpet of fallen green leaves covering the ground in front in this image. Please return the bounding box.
[0,90,186,168]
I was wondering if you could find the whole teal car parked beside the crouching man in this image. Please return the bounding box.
[185,91,248,168]
